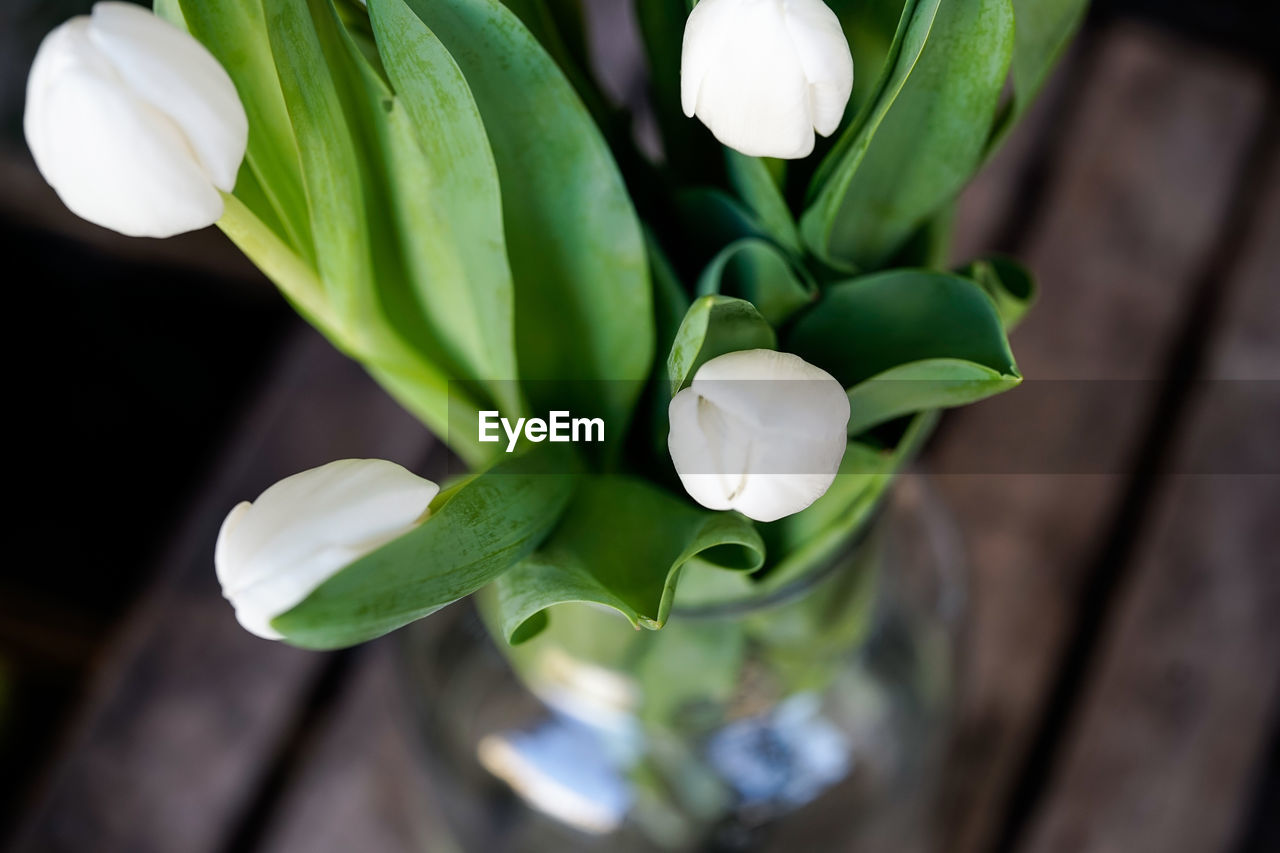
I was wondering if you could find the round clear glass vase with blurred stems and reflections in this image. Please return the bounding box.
[404,475,964,853]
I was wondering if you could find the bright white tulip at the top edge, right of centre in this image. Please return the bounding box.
[680,0,854,160]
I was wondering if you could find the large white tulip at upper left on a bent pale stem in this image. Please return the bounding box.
[23,3,248,237]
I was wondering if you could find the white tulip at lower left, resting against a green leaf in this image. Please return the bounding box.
[214,459,440,639]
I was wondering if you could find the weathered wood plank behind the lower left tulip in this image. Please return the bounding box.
[17,329,430,853]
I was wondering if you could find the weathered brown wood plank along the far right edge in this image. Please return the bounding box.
[1025,144,1280,853]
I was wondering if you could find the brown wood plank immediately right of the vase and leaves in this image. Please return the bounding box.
[932,26,1262,852]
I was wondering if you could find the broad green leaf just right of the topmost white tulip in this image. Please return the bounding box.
[801,0,1014,269]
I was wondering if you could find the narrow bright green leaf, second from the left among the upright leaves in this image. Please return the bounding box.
[262,0,485,464]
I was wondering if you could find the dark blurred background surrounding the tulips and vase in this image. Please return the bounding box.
[0,0,1280,853]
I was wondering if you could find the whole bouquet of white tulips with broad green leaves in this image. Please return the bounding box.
[26,0,1084,648]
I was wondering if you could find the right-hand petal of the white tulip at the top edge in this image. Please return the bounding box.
[786,0,854,136]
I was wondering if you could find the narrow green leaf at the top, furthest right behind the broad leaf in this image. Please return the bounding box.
[988,0,1089,150]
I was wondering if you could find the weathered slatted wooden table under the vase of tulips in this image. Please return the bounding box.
[0,6,1280,853]
